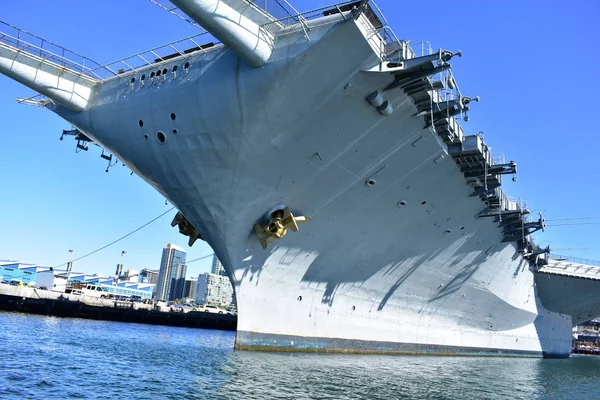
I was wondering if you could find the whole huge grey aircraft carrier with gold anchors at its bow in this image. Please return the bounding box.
[0,0,600,357]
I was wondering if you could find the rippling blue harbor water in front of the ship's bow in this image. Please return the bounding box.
[0,312,600,399]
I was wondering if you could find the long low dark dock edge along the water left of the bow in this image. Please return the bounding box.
[0,284,237,331]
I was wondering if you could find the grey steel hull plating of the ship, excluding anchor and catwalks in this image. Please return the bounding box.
[8,8,571,356]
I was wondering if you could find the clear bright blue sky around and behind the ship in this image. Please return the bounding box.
[0,0,600,276]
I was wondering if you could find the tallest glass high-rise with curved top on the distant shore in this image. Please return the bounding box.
[156,243,187,300]
